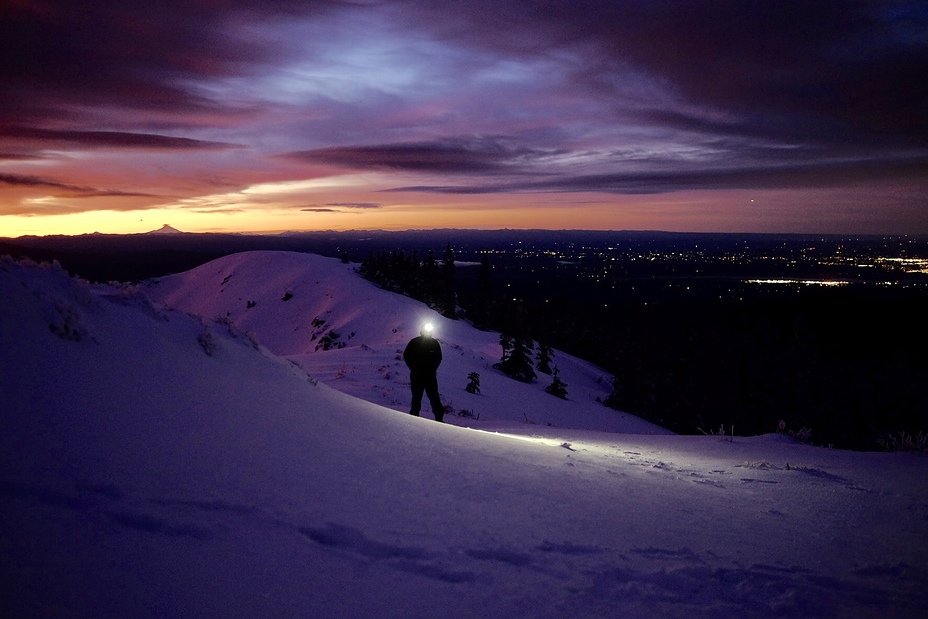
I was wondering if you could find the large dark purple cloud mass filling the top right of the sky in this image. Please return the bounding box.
[404,0,928,145]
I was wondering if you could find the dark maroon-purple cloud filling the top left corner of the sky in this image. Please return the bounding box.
[0,0,339,121]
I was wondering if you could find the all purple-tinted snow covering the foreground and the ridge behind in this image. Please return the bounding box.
[0,252,928,617]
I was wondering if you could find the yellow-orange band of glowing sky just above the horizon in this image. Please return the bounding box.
[0,179,928,238]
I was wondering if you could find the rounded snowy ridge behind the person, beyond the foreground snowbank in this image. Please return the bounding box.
[146,251,667,434]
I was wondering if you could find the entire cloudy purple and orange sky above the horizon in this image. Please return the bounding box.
[0,0,928,237]
